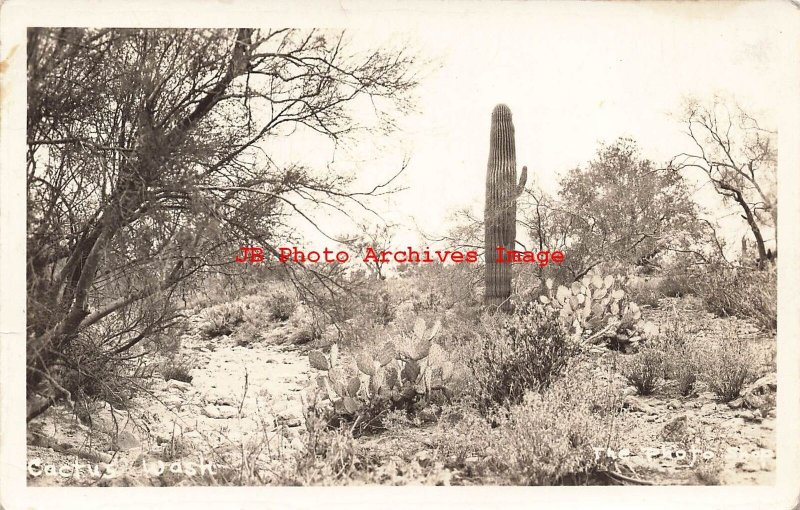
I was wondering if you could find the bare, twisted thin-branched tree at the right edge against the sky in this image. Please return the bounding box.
[671,98,778,267]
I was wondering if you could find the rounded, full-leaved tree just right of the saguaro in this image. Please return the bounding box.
[525,138,700,279]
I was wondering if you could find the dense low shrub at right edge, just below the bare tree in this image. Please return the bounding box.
[694,266,778,331]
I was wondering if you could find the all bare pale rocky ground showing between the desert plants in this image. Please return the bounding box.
[28,294,776,486]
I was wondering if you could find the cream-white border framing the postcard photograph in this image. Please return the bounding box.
[0,0,800,510]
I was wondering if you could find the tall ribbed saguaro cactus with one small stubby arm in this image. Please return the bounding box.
[484,104,528,310]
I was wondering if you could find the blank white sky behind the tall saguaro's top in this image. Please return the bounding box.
[264,2,789,255]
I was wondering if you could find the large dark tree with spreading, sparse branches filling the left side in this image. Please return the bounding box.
[27,28,416,418]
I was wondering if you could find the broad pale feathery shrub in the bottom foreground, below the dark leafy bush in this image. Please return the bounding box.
[434,367,621,485]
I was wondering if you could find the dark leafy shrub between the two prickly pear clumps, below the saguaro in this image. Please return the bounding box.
[468,305,578,413]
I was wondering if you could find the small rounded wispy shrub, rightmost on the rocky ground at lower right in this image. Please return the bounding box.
[699,337,758,402]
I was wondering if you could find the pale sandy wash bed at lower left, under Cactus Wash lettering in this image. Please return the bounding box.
[28,318,311,485]
